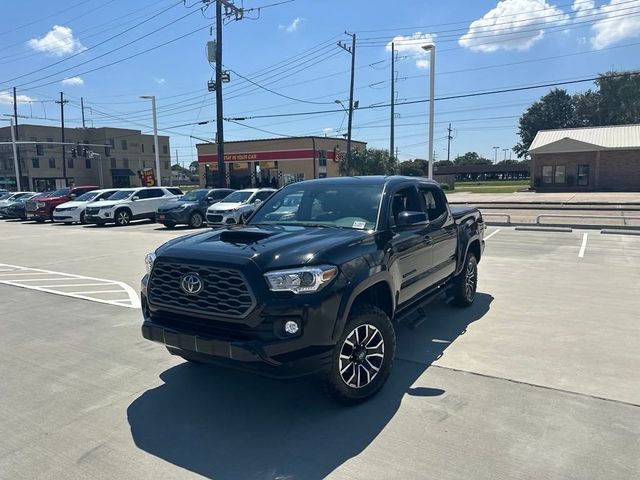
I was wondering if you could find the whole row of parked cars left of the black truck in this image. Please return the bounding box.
[0,185,276,228]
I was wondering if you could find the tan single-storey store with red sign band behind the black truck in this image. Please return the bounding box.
[196,137,366,188]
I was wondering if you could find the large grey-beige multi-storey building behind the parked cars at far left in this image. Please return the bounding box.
[0,125,171,191]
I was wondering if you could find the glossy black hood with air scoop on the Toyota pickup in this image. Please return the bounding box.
[157,225,373,271]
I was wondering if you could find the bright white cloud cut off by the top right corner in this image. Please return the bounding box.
[578,0,640,49]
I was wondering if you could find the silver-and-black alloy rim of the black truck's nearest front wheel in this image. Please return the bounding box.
[338,323,384,388]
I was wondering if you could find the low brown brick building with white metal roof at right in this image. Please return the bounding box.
[529,125,640,192]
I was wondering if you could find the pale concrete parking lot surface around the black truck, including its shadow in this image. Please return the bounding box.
[0,221,640,480]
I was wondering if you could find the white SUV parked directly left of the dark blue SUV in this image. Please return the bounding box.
[85,187,177,226]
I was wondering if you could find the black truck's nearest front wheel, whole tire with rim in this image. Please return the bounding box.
[324,303,396,405]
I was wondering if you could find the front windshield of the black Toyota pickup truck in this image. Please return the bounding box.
[249,183,382,230]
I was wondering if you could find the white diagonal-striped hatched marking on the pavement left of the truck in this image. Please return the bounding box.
[0,263,140,309]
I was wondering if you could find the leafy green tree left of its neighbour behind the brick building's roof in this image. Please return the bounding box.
[513,88,578,158]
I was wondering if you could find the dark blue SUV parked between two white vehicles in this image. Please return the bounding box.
[156,188,234,228]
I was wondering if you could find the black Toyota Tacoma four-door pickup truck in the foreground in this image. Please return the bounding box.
[142,176,485,404]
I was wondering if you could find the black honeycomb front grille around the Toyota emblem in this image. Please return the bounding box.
[148,262,256,318]
